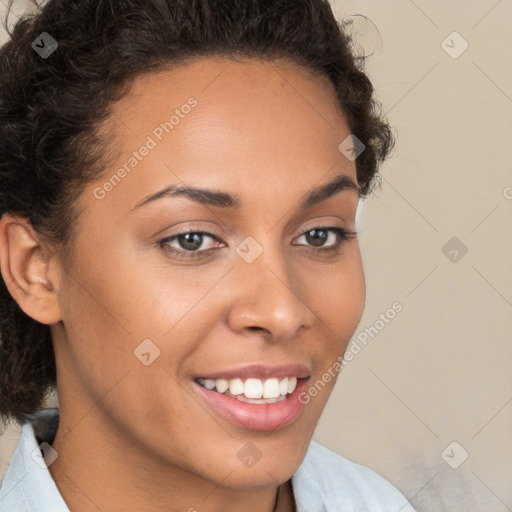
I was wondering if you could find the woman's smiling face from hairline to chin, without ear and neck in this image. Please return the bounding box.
[52,58,365,488]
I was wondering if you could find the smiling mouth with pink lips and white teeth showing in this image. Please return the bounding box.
[194,365,310,430]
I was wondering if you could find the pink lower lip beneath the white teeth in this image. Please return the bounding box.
[194,379,308,430]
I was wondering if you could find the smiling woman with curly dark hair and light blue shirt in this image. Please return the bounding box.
[0,0,413,512]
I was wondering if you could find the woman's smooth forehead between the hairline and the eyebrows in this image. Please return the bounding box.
[84,58,355,214]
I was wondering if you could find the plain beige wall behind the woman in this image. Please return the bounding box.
[0,0,512,512]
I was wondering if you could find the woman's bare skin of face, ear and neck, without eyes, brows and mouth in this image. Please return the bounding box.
[0,58,365,512]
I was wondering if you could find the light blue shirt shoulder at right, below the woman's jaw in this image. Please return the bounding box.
[292,441,414,512]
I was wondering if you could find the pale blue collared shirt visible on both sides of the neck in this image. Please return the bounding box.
[0,409,415,512]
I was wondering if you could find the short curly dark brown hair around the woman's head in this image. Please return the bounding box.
[0,0,394,423]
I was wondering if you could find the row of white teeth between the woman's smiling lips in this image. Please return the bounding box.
[198,377,297,403]
